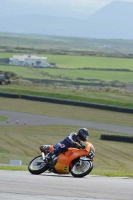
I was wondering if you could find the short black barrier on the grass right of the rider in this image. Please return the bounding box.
[101,135,133,143]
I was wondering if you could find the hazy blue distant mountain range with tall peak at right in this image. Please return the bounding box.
[0,1,133,39]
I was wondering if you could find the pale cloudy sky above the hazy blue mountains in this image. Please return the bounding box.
[0,0,133,19]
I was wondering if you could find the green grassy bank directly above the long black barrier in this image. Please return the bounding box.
[0,81,133,108]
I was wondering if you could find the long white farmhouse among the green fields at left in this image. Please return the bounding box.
[9,55,50,67]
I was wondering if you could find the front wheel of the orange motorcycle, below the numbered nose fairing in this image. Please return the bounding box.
[70,160,93,178]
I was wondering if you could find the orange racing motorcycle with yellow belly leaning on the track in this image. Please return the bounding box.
[28,142,95,177]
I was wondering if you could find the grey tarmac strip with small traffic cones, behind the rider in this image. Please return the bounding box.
[0,110,133,135]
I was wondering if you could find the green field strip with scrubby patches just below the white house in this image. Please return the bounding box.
[0,65,133,83]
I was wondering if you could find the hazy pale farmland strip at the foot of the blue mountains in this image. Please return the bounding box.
[0,33,133,56]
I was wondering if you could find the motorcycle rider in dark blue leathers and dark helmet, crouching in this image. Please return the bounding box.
[46,128,92,162]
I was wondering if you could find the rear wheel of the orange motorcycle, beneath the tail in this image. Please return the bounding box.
[28,155,49,175]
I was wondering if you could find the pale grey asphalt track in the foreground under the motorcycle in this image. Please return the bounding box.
[0,170,133,200]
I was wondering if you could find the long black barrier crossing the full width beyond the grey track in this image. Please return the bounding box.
[0,92,133,113]
